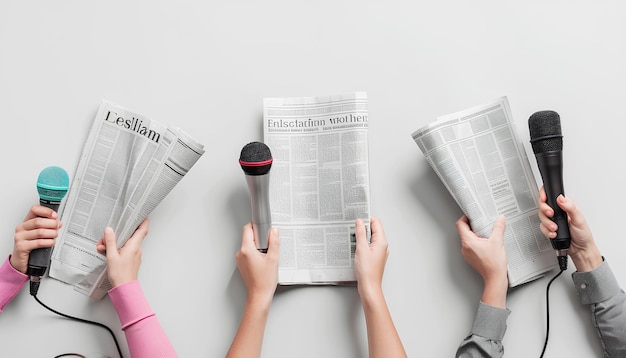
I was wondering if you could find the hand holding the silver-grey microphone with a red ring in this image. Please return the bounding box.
[235,222,280,303]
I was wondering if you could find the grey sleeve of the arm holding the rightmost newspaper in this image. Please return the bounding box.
[456,302,511,358]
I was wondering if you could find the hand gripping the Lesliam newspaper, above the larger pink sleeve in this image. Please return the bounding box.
[96,217,150,287]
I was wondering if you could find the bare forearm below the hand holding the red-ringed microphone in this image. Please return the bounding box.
[226,297,272,358]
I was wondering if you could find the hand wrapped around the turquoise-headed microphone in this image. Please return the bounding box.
[10,205,63,274]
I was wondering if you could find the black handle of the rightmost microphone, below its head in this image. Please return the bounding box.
[535,151,571,251]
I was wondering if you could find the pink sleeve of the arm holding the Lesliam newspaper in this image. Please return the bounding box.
[109,280,178,358]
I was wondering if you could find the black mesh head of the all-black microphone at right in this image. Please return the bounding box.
[528,111,563,154]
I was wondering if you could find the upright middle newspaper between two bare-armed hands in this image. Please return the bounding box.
[263,92,370,285]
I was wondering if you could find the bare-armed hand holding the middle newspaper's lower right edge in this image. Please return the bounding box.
[354,218,389,296]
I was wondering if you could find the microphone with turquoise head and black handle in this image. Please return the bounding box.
[26,166,70,296]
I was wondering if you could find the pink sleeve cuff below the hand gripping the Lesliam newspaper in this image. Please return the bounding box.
[109,280,154,330]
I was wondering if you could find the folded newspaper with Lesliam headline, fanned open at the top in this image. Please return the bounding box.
[50,100,204,299]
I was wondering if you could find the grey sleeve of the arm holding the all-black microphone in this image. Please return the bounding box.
[572,261,626,358]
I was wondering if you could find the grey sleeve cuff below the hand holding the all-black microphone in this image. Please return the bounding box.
[572,261,620,305]
